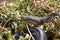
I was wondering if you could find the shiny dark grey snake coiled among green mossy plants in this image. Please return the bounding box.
[15,12,60,40]
